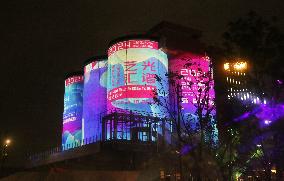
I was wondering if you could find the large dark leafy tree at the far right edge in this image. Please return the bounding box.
[220,12,284,180]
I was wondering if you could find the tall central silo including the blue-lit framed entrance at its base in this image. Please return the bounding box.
[103,36,170,142]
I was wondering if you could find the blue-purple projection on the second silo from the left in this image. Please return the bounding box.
[82,59,107,142]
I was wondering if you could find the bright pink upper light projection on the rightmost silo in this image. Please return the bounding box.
[170,53,215,114]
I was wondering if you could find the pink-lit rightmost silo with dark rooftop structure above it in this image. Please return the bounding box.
[149,22,218,142]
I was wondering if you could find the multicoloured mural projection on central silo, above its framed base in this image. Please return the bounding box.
[107,39,168,116]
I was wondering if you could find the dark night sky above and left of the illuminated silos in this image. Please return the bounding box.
[0,0,284,165]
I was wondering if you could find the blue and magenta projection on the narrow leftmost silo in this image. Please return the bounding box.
[62,75,84,149]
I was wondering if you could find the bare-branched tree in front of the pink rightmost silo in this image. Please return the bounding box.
[154,53,217,179]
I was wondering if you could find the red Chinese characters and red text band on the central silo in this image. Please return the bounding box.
[108,60,157,104]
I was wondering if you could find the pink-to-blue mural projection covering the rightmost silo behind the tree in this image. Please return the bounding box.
[170,53,218,141]
